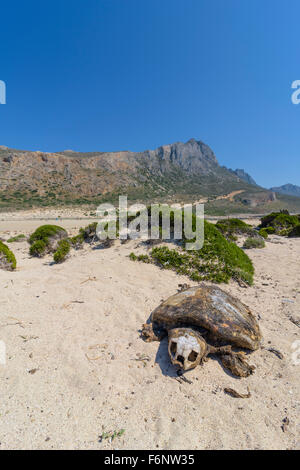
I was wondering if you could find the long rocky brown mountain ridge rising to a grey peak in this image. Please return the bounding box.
[0,139,298,211]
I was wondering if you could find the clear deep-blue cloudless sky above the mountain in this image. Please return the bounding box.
[0,0,300,187]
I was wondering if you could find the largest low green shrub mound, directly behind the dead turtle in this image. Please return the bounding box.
[130,221,254,285]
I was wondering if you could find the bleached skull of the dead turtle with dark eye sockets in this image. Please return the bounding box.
[168,328,207,370]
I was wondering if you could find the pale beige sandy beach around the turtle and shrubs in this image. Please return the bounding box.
[0,214,300,450]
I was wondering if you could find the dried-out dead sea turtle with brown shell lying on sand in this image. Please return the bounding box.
[142,285,261,377]
